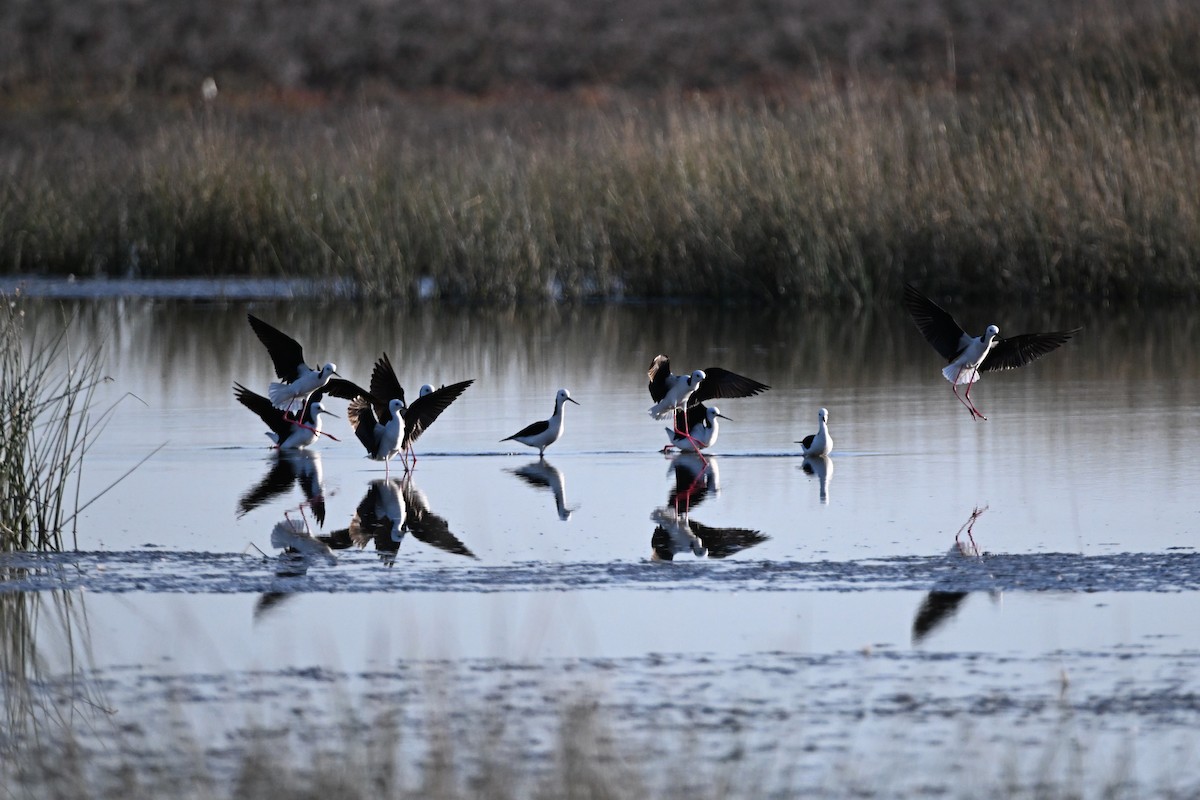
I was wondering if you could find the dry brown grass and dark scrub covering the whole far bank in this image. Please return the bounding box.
[0,0,1200,305]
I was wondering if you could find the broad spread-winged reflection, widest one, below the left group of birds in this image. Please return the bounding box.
[322,474,475,566]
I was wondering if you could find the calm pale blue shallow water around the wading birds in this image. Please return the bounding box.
[2,291,1200,788]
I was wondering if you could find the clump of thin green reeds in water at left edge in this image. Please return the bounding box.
[0,295,108,551]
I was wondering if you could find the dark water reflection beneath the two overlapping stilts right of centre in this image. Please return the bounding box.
[650,453,768,561]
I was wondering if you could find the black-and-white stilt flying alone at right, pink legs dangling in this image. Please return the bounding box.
[904,283,1084,420]
